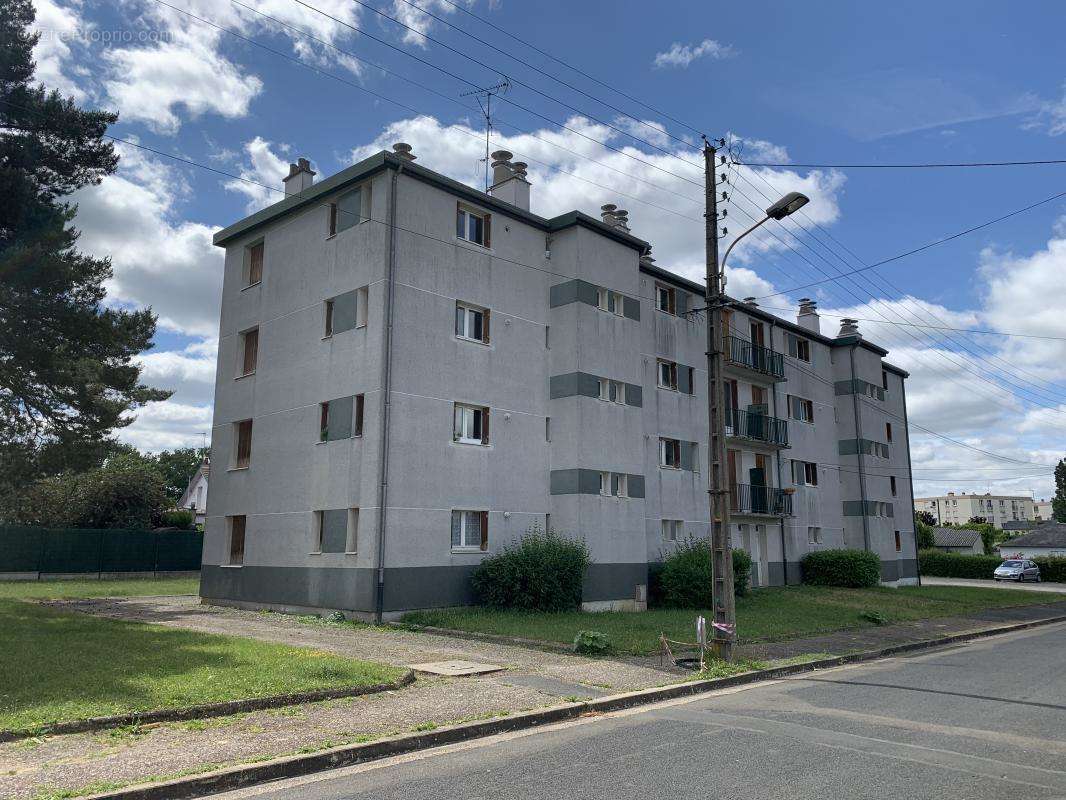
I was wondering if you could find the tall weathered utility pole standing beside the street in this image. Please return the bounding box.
[704,137,737,661]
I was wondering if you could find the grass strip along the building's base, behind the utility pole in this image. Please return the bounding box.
[403,587,1066,655]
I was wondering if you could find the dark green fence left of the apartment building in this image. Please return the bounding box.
[0,527,204,573]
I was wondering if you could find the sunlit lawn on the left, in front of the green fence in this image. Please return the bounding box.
[0,580,403,730]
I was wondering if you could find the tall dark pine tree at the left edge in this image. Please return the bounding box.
[0,0,169,492]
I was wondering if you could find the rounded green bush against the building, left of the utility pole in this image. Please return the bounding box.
[471,526,591,611]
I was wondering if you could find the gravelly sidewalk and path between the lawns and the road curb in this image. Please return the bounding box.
[8,597,1066,800]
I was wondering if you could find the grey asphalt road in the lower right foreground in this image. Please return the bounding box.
[220,624,1066,800]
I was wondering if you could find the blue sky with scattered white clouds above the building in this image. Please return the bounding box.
[27,0,1066,497]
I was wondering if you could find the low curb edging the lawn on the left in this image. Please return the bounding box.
[0,670,415,742]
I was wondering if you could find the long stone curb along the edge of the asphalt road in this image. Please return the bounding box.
[85,614,1066,800]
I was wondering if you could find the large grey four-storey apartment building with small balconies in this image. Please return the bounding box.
[200,144,917,618]
